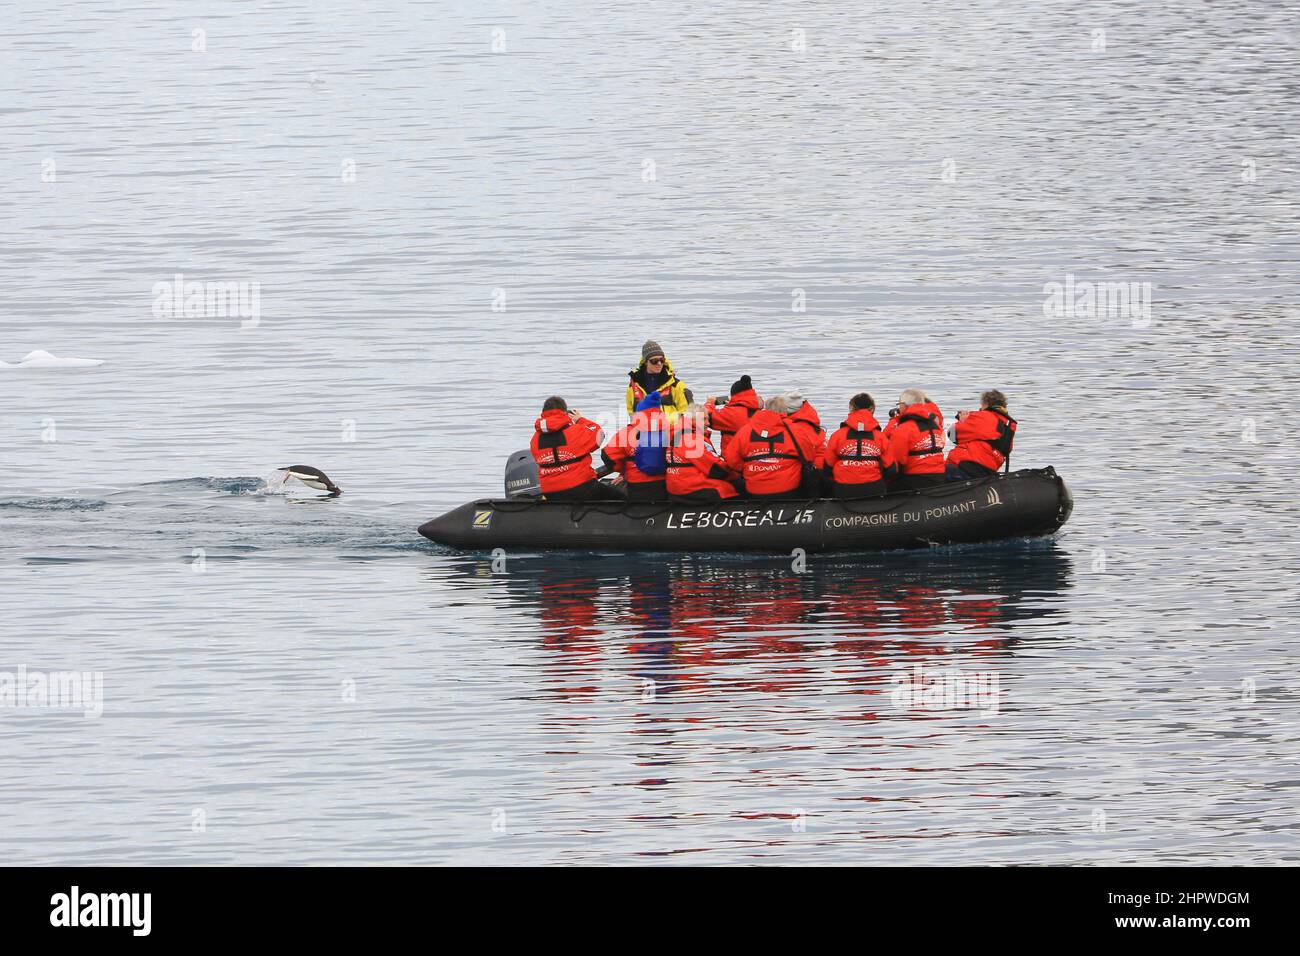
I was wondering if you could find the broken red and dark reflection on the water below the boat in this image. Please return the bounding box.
[441,540,1071,696]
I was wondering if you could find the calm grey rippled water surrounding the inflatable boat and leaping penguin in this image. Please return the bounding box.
[0,0,1300,864]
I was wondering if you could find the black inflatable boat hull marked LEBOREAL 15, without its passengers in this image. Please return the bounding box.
[420,467,1074,553]
